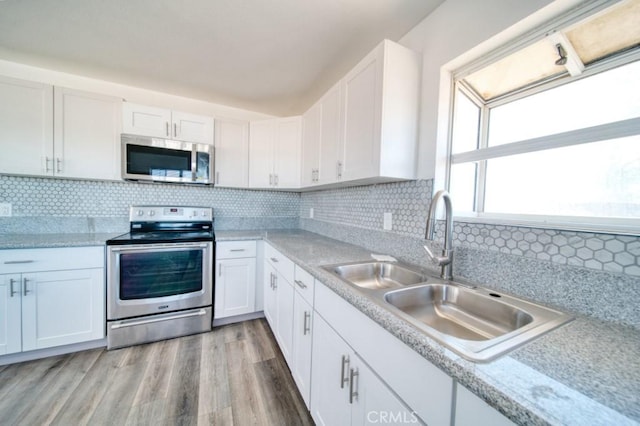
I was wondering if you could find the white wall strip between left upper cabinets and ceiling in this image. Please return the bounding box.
[0,60,271,120]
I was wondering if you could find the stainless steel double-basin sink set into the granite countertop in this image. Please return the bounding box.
[323,261,573,362]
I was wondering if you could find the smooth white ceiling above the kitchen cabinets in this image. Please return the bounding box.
[0,0,444,115]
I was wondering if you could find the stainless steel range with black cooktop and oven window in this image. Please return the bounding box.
[107,206,215,349]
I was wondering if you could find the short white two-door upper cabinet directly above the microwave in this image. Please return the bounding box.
[122,102,213,145]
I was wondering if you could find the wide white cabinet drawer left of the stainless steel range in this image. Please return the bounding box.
[0,246,104,274]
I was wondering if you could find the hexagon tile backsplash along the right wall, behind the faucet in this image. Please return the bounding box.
[300,180,640,276]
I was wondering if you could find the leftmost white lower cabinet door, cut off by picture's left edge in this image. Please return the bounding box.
[0,274,22,355]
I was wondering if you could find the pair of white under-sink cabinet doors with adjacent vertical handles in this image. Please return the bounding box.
[311,316,419,426]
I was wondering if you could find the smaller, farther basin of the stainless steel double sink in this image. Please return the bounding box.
[328,262,427,289]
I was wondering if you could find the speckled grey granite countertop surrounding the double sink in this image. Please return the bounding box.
[216,230,640,426]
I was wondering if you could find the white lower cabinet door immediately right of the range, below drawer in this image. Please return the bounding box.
[214,258,256,318]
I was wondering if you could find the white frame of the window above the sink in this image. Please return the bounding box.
[444,1,640,235]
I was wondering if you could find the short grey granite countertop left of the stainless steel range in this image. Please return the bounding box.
[0,233,122,250]
